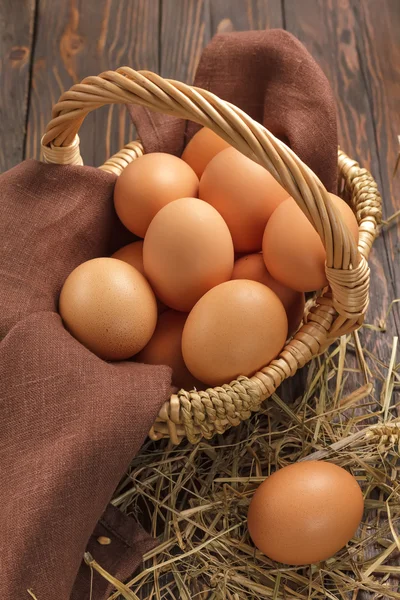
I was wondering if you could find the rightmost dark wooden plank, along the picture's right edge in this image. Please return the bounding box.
[353,0,400,300]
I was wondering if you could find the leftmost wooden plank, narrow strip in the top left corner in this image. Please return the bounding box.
[0,0,35,173]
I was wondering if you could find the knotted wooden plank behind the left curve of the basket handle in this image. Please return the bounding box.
[27,0,159,166]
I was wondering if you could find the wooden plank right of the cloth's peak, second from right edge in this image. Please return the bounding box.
[284,0,399,361]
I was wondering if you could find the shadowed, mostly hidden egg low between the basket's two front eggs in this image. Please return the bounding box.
[135,310,204,390]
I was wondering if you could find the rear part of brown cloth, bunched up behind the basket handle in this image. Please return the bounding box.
[128,29,337,192]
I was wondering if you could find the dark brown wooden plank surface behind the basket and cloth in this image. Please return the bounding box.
[0,0,400,596]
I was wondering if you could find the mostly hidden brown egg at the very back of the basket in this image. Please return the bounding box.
[182,127,230,179]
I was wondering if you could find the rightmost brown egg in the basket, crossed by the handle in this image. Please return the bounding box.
[263,194,358,292]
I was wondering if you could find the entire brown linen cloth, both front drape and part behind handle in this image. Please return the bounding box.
[0,31,337,600]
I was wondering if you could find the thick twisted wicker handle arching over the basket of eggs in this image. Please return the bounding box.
[42,67,369,323]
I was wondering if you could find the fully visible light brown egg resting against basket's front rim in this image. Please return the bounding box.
[182,279,288,386]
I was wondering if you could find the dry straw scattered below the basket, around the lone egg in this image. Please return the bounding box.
[88,308,400,600]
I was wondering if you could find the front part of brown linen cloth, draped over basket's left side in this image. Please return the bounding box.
[0,161,170,600]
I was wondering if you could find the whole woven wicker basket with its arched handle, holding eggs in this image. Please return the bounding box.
[42,67,381,444]
